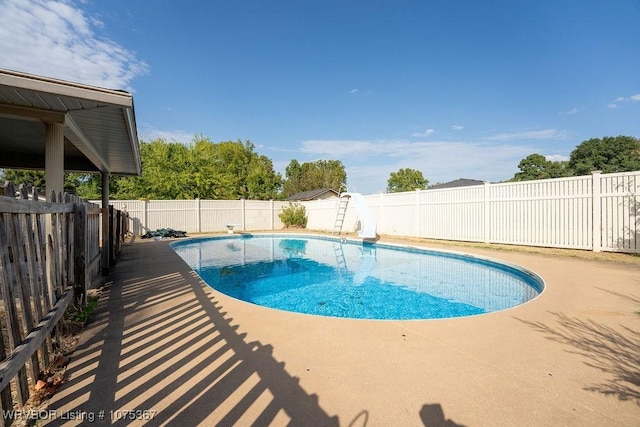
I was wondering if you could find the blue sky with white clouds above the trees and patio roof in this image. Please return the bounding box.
[0,0,640,194]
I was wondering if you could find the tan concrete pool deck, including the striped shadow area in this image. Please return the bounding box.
[48,239,640,426]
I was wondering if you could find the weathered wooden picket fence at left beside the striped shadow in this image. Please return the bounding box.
[0,183,128,425]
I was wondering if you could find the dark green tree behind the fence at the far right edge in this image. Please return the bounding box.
[569,136,640,175]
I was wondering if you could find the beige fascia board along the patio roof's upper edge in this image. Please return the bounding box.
[0,69,133,107]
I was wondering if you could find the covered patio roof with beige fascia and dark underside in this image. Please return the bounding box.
[0,69,141,175]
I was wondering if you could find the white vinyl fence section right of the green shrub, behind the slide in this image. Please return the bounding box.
[305,171,640,253]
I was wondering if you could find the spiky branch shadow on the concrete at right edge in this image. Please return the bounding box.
[516,312,640,405]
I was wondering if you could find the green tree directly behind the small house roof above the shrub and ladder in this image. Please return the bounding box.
[283,159,347,198]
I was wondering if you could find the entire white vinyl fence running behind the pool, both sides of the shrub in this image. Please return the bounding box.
[101,171,640,253]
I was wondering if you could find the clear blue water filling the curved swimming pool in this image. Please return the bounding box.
[173,235,543,320]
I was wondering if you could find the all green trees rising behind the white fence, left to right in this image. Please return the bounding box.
[0,135,640,200]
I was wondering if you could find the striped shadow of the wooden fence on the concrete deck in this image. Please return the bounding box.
[49,241,339,426]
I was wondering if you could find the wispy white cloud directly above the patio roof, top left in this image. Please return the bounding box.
[0,0,148,91]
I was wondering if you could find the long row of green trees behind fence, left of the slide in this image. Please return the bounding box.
[0,135,347,200]
